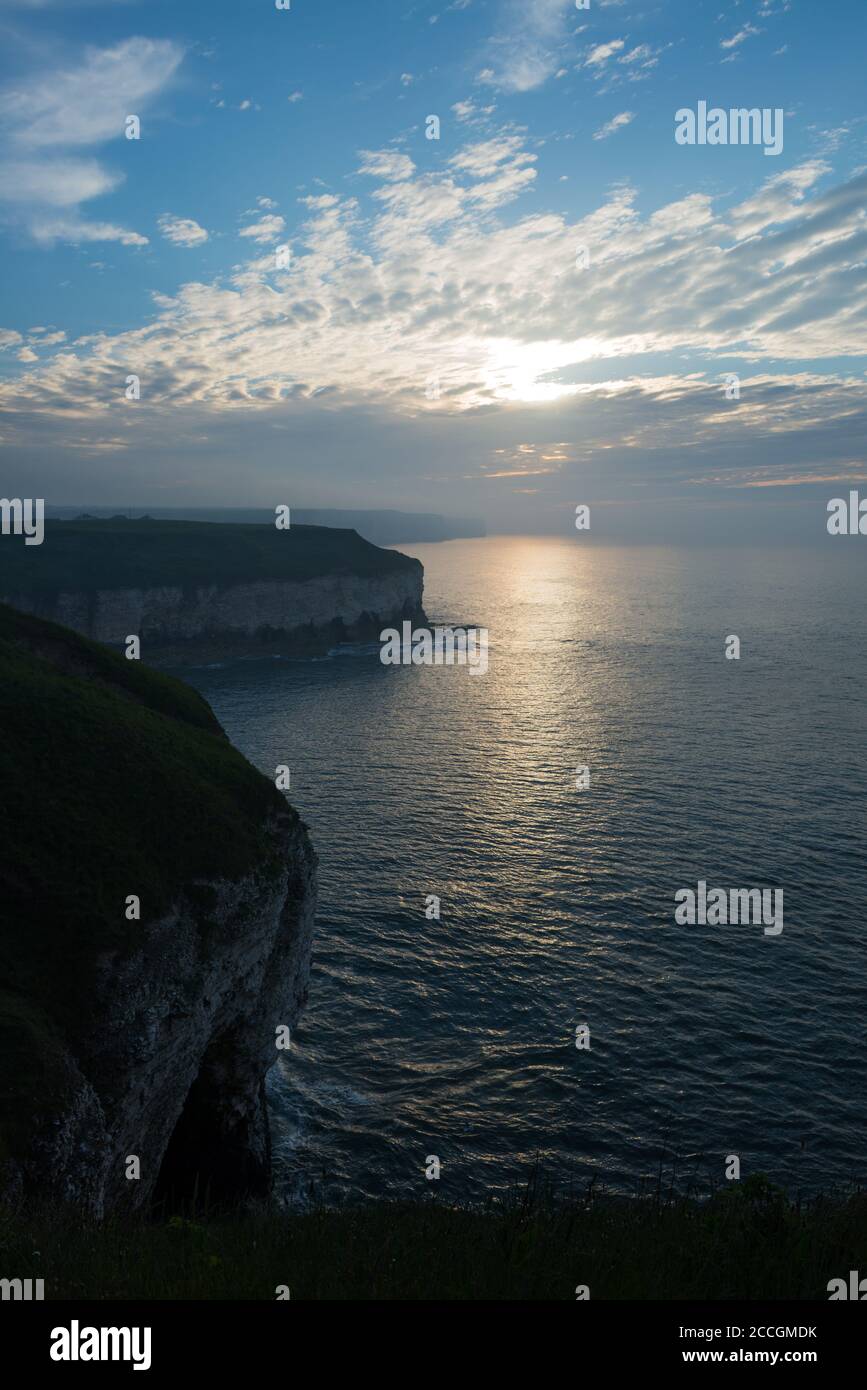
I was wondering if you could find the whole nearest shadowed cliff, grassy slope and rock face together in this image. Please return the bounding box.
[0,606,315,1218]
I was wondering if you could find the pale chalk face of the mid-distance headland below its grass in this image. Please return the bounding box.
[4,566,424,644]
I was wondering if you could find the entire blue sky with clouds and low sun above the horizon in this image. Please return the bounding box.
[0,0,867,541]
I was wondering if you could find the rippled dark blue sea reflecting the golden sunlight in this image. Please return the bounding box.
[183,535,867,1201]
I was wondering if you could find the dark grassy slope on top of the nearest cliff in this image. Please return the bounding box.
[0,605,295,1173]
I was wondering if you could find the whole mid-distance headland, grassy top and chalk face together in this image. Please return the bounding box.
[0,517,424,659]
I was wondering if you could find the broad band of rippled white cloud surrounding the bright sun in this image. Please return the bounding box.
[0,131,867,511]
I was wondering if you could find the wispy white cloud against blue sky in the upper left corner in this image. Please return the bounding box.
[0,38,182,246]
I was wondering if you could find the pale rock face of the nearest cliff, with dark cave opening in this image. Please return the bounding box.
[11,812,315,1218]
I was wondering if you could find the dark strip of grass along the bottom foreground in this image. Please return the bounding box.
[0,1176,867,1301]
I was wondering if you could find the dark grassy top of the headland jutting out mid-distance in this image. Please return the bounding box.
[0,517,420,598]
